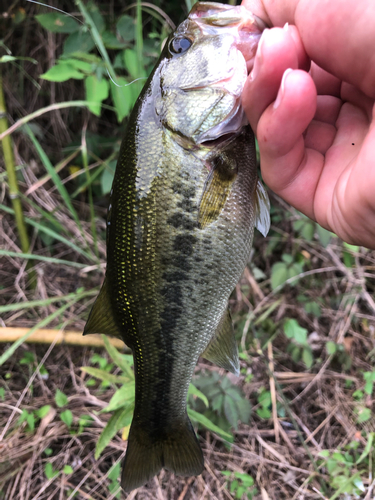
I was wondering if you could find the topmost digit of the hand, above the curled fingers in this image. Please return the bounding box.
[243,0,375,97]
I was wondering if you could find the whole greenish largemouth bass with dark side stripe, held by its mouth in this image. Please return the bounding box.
[84,2,270,492]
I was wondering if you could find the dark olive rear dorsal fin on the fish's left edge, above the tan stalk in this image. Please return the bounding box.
[83,280,122,339]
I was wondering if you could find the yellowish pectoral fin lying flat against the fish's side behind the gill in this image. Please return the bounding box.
[198,153,237,229]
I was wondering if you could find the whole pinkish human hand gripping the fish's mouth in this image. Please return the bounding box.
[243,0,375,249]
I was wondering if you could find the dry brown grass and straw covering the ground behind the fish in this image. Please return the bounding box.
[0,204,375,500]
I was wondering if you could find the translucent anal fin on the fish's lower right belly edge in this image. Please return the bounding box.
[202,309,240,375]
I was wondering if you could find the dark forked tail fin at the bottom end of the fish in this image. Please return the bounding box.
[121,416,204,492]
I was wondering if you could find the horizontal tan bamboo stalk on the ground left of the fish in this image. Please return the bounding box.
[0,327,124,349]
